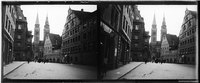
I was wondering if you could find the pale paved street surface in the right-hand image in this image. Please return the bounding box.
[121,62,196,79]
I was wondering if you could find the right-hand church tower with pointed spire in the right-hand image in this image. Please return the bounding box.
[160,15,167,42]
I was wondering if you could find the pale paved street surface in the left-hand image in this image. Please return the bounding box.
[5,62,97,79]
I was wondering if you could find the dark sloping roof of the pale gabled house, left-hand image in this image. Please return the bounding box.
[49,33,62,49]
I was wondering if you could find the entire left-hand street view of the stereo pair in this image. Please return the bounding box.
[2,4,97,80]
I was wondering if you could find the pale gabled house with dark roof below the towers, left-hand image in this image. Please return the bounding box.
[43,33,62,62]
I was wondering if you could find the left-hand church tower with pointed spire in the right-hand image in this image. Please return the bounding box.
[151,14,157,44]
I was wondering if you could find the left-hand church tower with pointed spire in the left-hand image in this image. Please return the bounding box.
[33,14,40,45]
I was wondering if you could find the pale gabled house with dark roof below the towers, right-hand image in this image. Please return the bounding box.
[160,34,179,63]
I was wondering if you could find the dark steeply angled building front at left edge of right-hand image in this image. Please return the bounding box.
[100,4,133,69]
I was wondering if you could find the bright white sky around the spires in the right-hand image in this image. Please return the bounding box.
[138,5,197,41]
